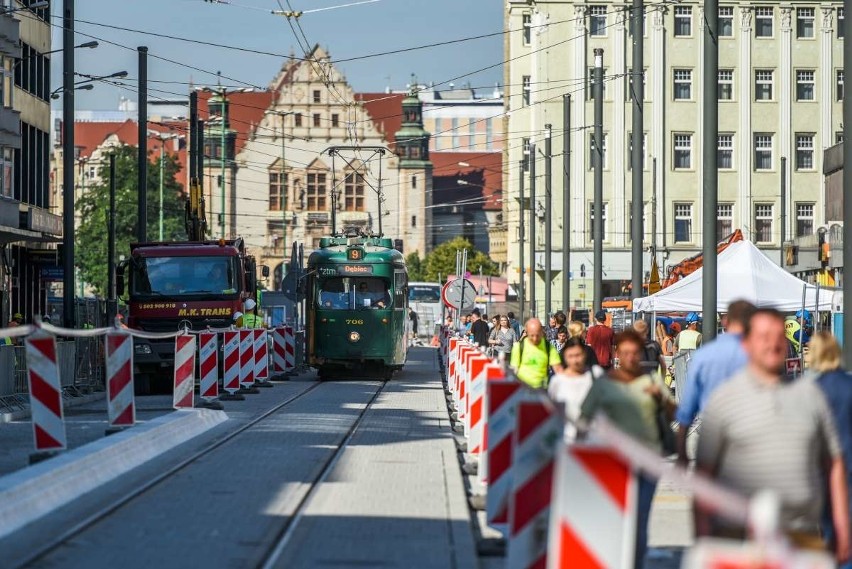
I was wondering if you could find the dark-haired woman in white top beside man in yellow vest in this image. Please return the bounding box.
[547,337,604,442]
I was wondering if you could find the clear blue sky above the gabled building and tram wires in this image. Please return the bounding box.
[51,0,503,110]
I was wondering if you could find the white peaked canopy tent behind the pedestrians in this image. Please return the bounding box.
[633,241,833,312]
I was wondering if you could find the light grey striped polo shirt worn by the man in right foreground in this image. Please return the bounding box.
[696,369,841,531]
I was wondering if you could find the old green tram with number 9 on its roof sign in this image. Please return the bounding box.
[306,235,408,379]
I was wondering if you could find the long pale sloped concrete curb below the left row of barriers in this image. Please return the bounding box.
[0,409,228,538]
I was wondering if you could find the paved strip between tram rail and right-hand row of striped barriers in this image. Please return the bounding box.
[277,348,478,569]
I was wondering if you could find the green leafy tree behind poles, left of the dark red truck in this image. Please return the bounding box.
[74,146,186,295]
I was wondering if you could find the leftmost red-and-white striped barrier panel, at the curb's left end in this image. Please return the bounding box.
[25,332,68,452]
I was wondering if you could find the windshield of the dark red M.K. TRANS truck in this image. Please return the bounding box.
[131,255,238,296]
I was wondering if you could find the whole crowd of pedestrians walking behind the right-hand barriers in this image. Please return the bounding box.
[469,301,852,569]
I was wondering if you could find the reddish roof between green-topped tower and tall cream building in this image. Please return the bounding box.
[429,152,503,211]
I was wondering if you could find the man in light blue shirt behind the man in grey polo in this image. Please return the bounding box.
[675,300,755,465]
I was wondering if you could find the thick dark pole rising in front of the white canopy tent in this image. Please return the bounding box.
[701,0,719,342]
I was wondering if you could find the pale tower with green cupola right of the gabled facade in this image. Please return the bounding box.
[394,76,432,258]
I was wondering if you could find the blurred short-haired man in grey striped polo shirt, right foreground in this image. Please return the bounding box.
[696,309,849,561]
